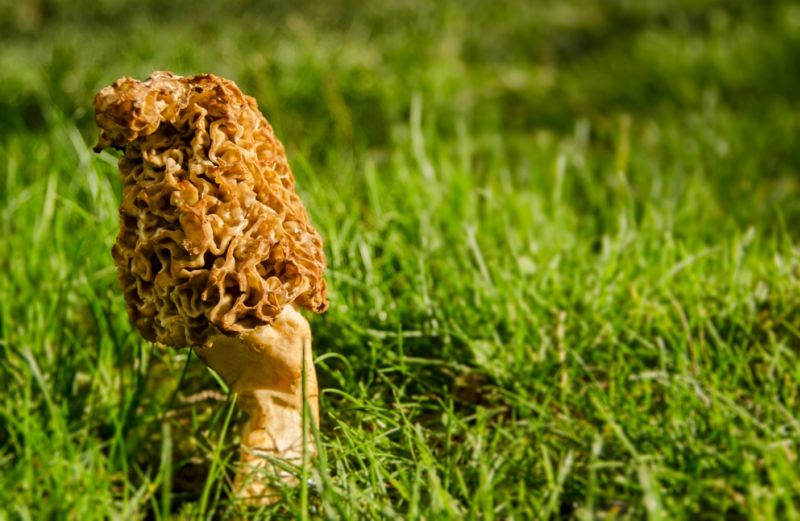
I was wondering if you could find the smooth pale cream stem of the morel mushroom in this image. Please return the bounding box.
[196,305,319,504]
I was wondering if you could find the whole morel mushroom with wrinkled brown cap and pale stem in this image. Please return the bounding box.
[94,72,328,502]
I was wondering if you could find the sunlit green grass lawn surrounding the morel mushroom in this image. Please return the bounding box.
[0,0,800,519]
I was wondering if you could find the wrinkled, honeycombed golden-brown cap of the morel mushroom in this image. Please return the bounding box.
[94,72,328,347]
